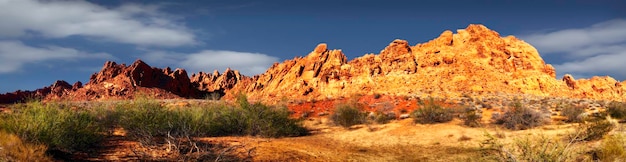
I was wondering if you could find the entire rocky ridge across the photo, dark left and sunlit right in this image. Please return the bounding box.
[0,24,626,102]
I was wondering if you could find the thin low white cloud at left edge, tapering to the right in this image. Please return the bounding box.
[0,41,113,74]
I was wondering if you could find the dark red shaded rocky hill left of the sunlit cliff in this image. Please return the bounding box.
[70,60,200,100]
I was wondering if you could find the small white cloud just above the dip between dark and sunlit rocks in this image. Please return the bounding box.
[144,50,279,76]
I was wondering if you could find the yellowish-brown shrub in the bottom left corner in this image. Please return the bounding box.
[0,131,52,161]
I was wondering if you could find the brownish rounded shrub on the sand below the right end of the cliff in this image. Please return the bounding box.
[495,101,546,130]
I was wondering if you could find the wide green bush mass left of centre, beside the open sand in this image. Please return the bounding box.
[118,96,308,143]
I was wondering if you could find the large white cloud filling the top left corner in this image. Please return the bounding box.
[0,0,197,47]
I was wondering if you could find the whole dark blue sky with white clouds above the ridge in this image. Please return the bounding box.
[0,0,626,93]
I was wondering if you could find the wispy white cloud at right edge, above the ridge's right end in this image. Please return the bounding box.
[521,19,626,80]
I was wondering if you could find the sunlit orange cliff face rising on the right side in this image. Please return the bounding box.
[234,25,626,101]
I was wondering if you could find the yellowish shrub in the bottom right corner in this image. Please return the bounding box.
[597,134,626,161]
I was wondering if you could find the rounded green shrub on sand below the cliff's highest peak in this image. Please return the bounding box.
[411,98,454,124]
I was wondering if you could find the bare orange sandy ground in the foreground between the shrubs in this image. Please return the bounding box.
[80,115,624,161]
